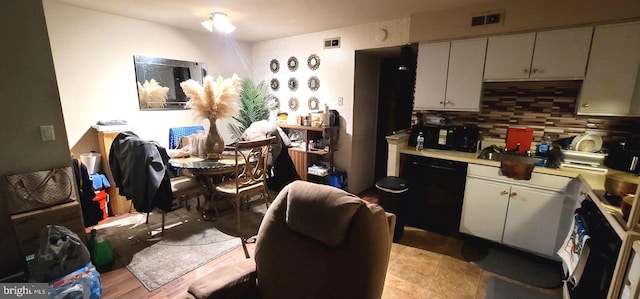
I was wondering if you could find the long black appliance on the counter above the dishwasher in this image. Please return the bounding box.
[409,125,480,153]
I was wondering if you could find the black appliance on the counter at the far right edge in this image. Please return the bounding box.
[604,139,640,174]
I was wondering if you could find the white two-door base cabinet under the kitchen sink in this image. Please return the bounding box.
[460,164,570,257]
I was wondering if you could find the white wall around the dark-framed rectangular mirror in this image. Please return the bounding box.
[44,1,252,155]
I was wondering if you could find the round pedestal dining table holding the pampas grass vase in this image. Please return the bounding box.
[169,151,244,220]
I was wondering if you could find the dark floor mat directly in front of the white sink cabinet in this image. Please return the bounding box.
[462,239,563,290]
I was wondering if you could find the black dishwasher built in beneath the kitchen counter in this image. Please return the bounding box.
[400,154,467,235]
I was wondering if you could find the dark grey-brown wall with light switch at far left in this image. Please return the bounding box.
[0,0,71,279]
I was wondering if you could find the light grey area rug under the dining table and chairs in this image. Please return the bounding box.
[95,204,266,291]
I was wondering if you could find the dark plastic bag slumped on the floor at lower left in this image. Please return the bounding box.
[31,225,91,282]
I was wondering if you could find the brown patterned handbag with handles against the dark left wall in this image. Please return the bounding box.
[7,167,77,214]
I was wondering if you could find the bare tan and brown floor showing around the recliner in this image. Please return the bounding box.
[91,189,561,299]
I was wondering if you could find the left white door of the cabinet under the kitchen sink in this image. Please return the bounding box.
[460,177,511,243]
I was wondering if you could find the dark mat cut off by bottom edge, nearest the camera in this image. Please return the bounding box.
[485,276,562,299]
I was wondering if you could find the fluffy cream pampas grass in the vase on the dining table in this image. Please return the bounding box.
[180,74,242,120]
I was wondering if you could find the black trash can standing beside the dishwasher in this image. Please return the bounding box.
[376,176,409,242]
